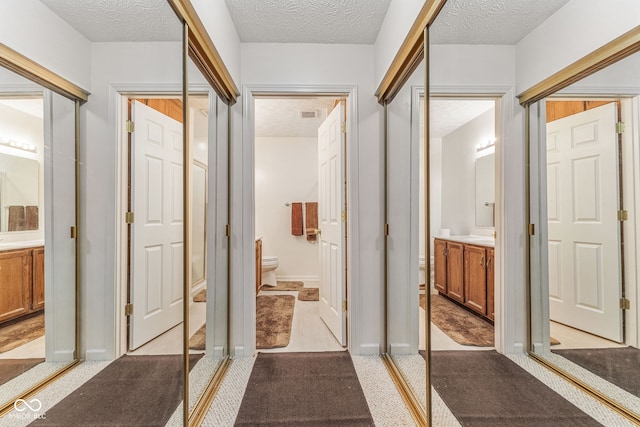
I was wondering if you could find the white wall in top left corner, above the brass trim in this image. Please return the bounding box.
[0,0,91,89]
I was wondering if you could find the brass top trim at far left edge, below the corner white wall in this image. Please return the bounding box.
[0,43,89,102]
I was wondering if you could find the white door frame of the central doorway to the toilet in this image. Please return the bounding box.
[241,85,360,357]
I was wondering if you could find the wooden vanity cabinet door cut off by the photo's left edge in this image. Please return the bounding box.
[0,249,31,322]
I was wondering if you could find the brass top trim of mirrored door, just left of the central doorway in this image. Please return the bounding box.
[168,0,240,104]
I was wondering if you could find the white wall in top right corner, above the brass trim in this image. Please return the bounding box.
[516,0,640,93]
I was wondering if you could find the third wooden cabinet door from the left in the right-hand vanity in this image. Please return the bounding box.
[464,245,487,315]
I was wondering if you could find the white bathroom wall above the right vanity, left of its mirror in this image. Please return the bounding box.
[441,108,495,235]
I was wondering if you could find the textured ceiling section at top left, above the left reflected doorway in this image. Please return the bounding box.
[40,0,182,42]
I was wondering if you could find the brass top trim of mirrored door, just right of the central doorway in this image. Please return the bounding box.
[375,0,447,104]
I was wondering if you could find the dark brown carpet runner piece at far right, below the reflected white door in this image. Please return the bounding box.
[553,347,640,397]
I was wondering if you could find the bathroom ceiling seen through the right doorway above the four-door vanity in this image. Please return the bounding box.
[430,99,495,138]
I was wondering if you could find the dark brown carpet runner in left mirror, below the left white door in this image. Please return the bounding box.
[30,354,202,427]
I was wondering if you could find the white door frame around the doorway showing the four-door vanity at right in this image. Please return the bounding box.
[422,86,508,354]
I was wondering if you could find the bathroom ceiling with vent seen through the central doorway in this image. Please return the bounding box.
[255,97,335,137]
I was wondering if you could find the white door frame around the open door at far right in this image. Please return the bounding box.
[529,93,640,353]
